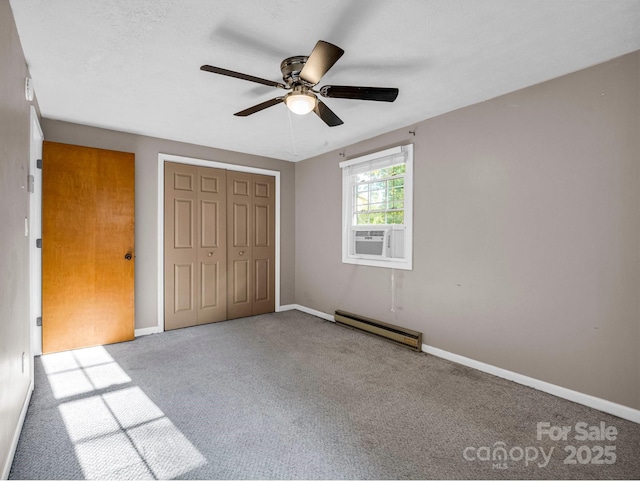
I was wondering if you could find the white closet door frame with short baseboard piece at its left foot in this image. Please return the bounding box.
[156,152,280,336]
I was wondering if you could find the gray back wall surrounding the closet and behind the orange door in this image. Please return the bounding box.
[42,119,295,329]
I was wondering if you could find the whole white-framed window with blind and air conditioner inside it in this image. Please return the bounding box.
[340,144,413,270]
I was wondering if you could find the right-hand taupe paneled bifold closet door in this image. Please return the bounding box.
[227,172,275,319]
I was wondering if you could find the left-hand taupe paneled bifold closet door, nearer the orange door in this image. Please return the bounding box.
[164,162,227,330]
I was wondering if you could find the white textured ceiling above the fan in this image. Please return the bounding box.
[10,0,640,161]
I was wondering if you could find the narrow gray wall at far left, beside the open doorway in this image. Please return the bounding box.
[0,1,32,476]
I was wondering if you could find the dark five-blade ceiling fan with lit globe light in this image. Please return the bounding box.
[200,40,398,127]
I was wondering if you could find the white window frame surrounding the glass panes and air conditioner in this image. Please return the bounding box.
[339,144,413,270]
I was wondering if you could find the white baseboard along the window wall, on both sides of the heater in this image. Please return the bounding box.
[288,304,640,424]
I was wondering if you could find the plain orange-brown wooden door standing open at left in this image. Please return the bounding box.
[42,142,135,353]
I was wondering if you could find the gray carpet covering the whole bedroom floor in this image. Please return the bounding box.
[10,311,640,479]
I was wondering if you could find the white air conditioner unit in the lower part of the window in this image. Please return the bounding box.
[350,225,405,259]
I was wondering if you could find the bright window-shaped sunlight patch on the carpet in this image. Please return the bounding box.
[42,346,207,479]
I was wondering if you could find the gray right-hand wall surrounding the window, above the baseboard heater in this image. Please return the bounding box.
[295,52,640,409]
